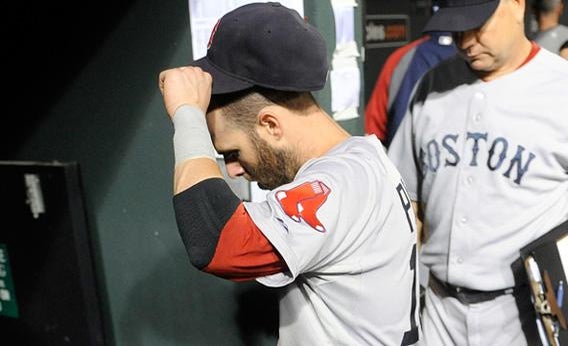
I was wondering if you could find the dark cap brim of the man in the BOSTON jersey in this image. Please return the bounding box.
[422,0,499,33]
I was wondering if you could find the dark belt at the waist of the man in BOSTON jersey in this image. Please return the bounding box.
[428,273,515,304]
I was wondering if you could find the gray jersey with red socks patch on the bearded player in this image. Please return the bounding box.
[245,135,419,345]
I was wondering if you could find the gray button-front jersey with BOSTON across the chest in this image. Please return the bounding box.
[389,49,568,290]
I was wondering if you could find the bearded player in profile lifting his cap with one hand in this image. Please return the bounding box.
[159,3,420,345]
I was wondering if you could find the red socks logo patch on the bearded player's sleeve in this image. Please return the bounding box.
[276,180,331,232]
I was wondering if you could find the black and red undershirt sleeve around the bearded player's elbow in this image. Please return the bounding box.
[173,178,284,280]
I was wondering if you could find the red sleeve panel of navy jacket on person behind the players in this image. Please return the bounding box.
[365,37,424,141]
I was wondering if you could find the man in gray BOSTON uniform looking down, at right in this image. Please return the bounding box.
[389,0,568,345]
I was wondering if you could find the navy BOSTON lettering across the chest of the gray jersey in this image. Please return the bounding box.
[419,132,536,185]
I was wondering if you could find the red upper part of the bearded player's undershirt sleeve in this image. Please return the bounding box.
[203,203,286,281]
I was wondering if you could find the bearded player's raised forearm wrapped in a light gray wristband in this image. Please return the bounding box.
[173,105,222,194]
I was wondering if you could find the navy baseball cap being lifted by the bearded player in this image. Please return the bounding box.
[190,2,329,95]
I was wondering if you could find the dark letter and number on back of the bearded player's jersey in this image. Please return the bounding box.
[396,181,418,346]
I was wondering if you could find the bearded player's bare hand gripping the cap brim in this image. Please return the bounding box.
[159,66,212,117]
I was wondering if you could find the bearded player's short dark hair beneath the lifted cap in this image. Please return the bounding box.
[207,87,319,131]
